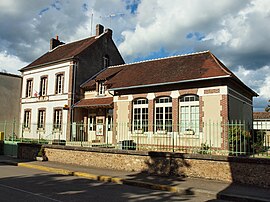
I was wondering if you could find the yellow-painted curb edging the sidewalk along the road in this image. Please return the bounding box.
[0,160,269,202]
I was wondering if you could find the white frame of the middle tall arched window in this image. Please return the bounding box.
[154,96,173,134]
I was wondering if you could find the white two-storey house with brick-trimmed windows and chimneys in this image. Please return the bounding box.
[20,25,124,140]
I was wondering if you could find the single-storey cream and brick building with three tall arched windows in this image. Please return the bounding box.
[75,51,257,149]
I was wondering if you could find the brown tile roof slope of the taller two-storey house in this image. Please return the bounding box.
[20,36,97,71]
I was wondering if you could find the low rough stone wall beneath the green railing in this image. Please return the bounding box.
[42,145,270,187]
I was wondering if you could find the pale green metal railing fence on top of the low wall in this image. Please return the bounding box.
[0,121,270,157]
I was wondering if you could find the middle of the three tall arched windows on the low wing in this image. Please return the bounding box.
[155,97,172,133]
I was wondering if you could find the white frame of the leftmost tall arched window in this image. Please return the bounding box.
[132,98,149,133]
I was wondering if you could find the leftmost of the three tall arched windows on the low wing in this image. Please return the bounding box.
[133,99,148,133]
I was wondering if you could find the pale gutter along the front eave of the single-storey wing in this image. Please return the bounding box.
[109,75,231,91]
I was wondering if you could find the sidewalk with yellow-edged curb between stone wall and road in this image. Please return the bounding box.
[0,155,270,201]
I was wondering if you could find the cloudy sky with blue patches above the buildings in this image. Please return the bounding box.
[0,0,270,111]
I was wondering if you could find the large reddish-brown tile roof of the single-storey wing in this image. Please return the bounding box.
[84,51,256,95]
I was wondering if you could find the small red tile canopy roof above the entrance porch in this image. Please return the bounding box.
[75,97,113,108]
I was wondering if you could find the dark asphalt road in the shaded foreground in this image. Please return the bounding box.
[0,164,217,202]
